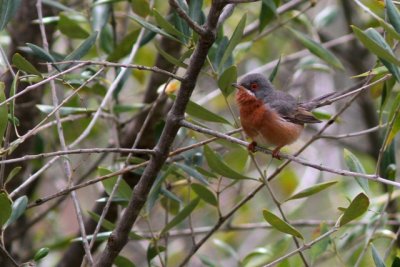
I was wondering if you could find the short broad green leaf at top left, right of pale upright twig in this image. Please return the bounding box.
[58,13,89,39]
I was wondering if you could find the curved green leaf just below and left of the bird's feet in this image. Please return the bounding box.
[204,145,254,180]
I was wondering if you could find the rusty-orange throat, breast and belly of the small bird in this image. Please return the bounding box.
[236,89,303,146]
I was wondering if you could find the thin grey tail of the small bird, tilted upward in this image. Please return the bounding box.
[300,83,363,110]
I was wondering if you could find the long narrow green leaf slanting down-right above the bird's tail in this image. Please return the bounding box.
[290,29,344,70]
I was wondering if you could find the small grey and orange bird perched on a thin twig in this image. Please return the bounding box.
[232,73,348,159]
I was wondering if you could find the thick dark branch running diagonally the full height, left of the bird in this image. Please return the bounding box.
[95,1,224,266]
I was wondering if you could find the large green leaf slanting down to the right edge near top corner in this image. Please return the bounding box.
[351,25,400,66]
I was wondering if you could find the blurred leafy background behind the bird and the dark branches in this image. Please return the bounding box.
[0,0,400,267]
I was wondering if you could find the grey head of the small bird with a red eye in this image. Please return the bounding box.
[236,73,274,99]
